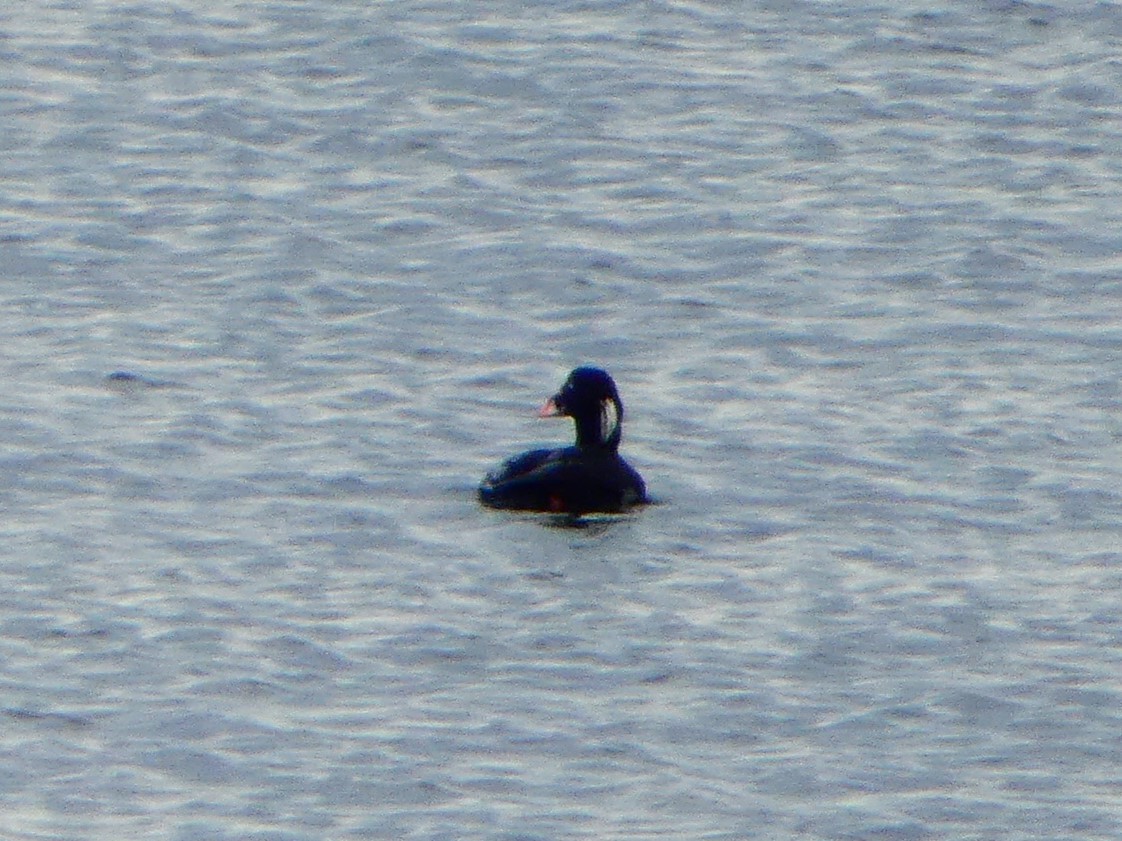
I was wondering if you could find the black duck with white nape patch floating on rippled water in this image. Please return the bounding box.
[479,366,649,516]
